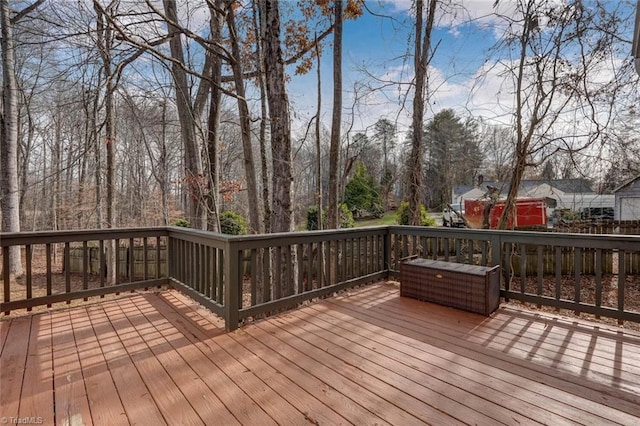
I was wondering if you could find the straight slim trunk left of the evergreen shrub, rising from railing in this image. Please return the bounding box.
[328,0,342,229]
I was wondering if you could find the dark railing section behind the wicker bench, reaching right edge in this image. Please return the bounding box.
[389,226,640,323]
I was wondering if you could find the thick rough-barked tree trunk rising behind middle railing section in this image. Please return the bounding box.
[261,0,293,232]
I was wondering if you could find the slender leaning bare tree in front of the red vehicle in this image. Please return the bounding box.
[496,0,622,228]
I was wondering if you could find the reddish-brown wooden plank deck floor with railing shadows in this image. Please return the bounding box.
[0,284,640,425]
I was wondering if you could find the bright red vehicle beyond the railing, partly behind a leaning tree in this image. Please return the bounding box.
[464,198,547,229]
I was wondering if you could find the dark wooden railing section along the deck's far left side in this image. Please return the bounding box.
[0,228,168,314]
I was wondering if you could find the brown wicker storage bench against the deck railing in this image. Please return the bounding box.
[400,259,500,316]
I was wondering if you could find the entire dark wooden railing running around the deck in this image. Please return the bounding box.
[0,226,640,330]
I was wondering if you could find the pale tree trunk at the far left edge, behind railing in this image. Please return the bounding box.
[0,0,22,277]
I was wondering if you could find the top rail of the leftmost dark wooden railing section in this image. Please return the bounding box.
[0,227,168,247]
